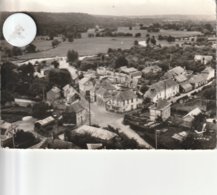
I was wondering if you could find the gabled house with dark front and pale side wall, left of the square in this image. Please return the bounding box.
[63,102,87,126]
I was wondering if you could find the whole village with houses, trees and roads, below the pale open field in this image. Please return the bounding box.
[0,21,216,149]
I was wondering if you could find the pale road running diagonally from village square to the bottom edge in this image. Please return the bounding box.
[116,119,154,149]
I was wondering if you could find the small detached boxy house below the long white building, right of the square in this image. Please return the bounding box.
[149,99,171,121]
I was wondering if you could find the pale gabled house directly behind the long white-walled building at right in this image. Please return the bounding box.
[164,66,187,83]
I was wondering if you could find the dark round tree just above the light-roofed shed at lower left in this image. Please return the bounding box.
[32,102,49,119]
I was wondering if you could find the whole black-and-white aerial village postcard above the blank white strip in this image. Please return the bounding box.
[0,0,217,150]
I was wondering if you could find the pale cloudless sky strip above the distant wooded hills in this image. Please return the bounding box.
[0,0,216,16]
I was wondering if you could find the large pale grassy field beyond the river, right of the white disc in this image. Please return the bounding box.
[9,37,144,61]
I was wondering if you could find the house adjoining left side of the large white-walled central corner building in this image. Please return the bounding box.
[95,79,116,105]
